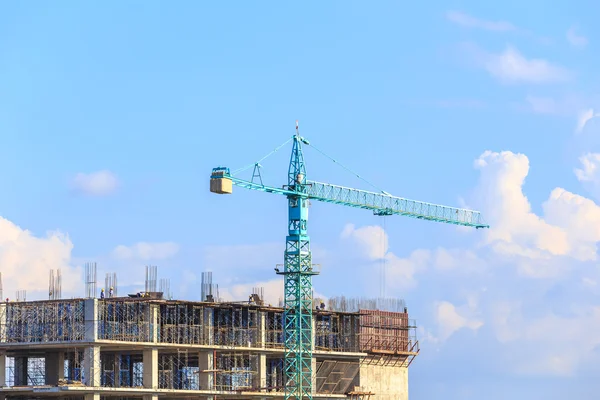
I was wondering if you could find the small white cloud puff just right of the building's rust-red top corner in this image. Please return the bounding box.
[435,301,483,342]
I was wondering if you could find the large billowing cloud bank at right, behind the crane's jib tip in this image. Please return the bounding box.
[344,151,600,376]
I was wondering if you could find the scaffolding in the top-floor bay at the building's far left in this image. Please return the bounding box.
[0,300,85,343]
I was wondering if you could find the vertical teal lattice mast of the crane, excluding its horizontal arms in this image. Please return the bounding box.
[278,122,317,400]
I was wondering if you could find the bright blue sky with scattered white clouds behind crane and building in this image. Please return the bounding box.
[0,0,600,400]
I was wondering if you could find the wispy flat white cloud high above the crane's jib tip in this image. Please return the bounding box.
[476,46,572,84]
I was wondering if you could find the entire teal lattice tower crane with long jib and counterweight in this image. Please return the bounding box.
[210,121,489,400]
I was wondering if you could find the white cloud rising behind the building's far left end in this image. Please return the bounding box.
[0,217,83,299]
